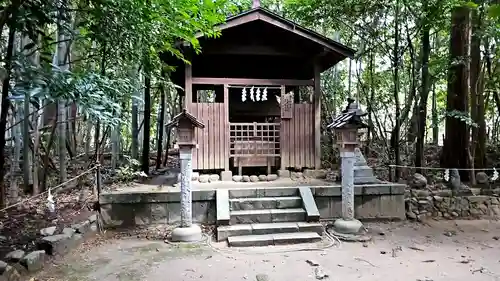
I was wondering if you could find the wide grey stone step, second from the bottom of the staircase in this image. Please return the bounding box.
[217,222,323,241]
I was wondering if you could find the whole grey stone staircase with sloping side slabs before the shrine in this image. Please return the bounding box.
[216,187,323,247]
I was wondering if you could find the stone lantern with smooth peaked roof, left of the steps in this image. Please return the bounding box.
[166,109,205,242]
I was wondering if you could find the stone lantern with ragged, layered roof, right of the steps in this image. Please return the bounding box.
[327,99,368,241]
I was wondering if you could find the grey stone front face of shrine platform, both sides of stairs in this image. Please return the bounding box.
[99,184,405,227]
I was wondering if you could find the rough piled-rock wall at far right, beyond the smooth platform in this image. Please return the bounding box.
[405,189,500,220]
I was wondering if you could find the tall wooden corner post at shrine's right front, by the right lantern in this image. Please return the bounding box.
[313,61,321,166]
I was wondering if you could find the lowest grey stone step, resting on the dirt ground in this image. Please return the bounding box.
[227,232,321,247]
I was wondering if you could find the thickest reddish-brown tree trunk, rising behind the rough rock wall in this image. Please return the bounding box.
[441,6,470,181]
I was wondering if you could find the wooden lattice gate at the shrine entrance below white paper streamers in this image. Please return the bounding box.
[229,123,280,158]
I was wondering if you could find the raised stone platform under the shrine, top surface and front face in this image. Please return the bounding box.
[99,179,405,227]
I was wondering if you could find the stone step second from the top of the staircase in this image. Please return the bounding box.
[229,196,302,211]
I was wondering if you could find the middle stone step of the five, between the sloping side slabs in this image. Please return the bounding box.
[230,208,306,225]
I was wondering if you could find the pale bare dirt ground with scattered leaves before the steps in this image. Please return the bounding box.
[32,220,500,281]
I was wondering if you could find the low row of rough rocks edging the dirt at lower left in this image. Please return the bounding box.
[0,215,97,281]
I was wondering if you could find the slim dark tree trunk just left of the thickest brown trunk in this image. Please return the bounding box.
[415,0,431,173]
